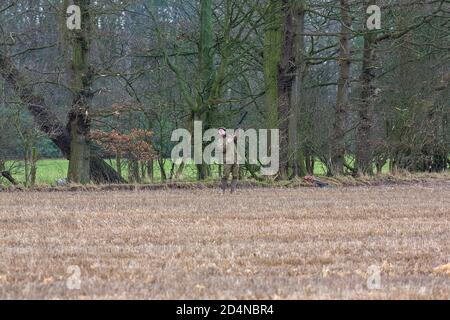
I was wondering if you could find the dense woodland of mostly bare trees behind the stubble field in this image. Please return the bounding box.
[0,0,450,184]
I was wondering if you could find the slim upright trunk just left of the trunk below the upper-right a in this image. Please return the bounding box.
[331,0,352,175]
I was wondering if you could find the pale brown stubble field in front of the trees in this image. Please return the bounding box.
[0,183,450,299]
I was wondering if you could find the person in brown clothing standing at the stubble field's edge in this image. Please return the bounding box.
[219,128,239,193]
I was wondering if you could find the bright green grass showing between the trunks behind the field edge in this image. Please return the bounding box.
[1,159,389,185]
